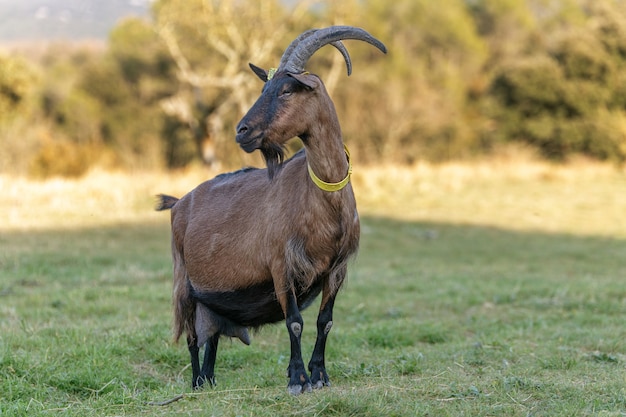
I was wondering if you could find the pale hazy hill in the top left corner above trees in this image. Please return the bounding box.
[0,0,151,43]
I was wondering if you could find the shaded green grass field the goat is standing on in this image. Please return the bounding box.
[0,167,626,417]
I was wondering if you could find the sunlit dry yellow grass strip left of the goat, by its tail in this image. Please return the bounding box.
[0,169,216,230]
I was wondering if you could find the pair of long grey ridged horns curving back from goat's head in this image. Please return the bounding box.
[278,26,387,75]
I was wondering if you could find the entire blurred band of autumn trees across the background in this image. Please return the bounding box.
[0,0,626,175]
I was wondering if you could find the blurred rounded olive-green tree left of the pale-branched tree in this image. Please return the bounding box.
[78,18,177,168]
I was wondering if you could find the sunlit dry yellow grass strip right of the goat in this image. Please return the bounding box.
[354,159,626,237]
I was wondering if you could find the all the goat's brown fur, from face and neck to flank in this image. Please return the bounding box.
[159,75,359,338]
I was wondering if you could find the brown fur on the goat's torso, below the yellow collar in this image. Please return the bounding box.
[162,154,359,330]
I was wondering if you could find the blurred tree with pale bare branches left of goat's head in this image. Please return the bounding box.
[154,0,310,165]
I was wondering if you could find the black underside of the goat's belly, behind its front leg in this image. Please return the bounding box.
[192,281,321,327]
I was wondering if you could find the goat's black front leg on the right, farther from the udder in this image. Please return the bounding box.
[309,290,335,388]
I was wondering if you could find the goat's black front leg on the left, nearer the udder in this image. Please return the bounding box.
[285,291,312,395]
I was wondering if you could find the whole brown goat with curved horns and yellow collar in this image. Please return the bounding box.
[156,26,387,395]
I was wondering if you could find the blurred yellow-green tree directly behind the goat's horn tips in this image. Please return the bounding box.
[335,0,487,163]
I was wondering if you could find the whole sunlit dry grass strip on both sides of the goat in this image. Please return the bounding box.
[0,158,626,236]
